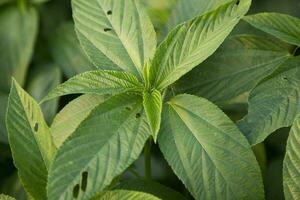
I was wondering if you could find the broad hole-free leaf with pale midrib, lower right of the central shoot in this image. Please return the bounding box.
[158,95,264,200]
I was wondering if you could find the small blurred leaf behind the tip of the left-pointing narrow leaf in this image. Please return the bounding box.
[26,64,62,123]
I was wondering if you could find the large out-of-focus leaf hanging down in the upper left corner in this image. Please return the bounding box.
[0,7,38,92]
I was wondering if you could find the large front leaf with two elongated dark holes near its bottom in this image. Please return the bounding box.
[48,94,150,200]
